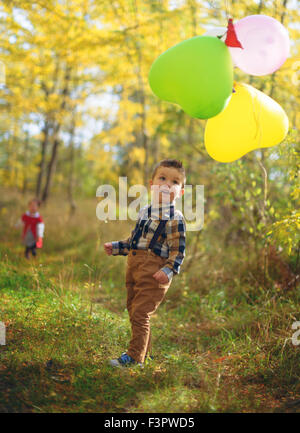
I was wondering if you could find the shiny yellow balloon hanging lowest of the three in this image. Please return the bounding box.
[204,83,289,162]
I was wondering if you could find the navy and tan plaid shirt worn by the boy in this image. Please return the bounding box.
[112,203,186,280]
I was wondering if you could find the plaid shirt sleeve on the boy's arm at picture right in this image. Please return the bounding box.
[161,217,186,281]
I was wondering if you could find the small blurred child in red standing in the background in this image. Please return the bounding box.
[21,199,45,259]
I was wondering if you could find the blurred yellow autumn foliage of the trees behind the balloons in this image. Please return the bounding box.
[0,0,300,208]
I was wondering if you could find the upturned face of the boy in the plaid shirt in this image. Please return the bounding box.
[149,167,184,204]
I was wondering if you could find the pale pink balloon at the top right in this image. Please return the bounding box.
[229,15,290,75]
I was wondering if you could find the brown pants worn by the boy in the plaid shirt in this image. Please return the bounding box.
[126,250,172,362]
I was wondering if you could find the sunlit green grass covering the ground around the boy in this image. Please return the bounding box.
[0,190,300,413]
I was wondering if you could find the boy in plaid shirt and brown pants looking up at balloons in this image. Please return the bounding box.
[104,159,186,367]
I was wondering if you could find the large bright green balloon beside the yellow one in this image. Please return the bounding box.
[149,36,233,119]
